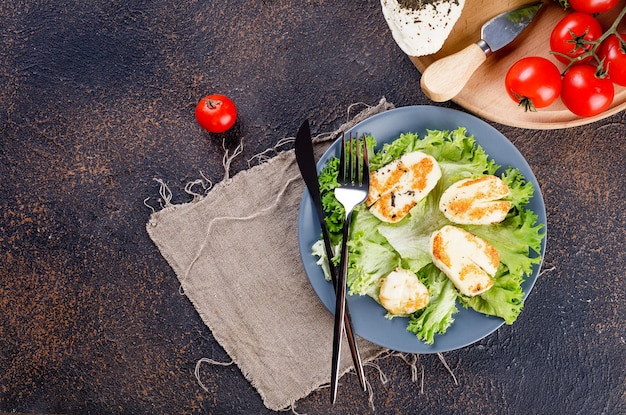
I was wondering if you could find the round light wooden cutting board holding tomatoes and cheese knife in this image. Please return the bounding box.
[410,0,626,129]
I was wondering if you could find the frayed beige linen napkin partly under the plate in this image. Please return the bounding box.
[146,98,393,410]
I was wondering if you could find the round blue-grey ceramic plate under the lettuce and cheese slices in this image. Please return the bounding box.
[298,106,547,353]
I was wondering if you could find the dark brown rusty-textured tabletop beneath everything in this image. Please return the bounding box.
[0,0,626,414]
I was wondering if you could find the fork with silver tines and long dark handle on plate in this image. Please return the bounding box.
[330,133,369,403]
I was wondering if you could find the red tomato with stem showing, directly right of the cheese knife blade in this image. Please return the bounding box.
[550,12,602,63]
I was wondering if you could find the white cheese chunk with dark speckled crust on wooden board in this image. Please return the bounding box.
[380,0,465,56]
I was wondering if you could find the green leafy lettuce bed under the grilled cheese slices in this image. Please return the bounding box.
[312,127,544,344]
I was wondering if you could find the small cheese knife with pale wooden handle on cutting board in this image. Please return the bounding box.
[420,1,543,102]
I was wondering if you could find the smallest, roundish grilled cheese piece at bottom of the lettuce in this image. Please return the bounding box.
[378,268,430,315]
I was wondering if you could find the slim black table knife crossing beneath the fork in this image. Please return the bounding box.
[295,120,367,391]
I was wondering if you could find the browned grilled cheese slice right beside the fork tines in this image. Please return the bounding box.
[365,151,441,223]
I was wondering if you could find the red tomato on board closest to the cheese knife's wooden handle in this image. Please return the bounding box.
[504,56,561,111]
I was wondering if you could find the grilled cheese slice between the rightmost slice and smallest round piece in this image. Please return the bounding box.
[430,225,500,297]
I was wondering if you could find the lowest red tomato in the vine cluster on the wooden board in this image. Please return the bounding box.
[561,64,615,117]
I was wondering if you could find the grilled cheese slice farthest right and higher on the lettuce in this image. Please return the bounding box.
[439,175,511,225]
